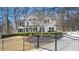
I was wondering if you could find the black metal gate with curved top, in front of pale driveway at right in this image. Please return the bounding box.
[57,34,79,51]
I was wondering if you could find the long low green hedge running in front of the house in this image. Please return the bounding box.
[1,32,63,38]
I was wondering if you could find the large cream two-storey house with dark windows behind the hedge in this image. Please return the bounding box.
[17,14,57,32]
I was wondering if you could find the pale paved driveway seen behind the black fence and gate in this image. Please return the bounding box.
[37,37,79,51]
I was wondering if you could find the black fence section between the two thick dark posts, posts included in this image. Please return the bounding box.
[34,34,59,51]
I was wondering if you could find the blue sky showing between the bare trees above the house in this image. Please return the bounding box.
[0,7,76,23]
